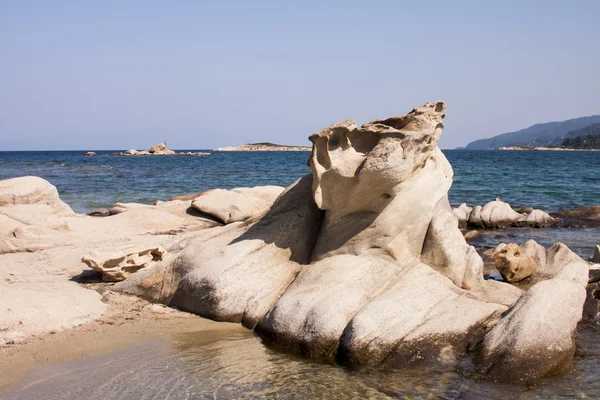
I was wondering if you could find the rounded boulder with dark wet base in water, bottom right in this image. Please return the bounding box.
[476,276,586,382]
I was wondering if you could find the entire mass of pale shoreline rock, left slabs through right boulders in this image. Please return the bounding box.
[0,101,598,390]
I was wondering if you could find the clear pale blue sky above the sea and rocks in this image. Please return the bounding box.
[0,0,600,150]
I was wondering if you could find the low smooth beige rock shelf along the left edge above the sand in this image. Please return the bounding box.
[0,177,220,347]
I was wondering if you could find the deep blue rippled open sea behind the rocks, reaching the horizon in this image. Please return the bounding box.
[0,150,600,212]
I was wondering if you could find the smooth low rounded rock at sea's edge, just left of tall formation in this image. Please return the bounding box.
[192,186,284,224]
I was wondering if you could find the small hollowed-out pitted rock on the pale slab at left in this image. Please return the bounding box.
[81,247,166,282]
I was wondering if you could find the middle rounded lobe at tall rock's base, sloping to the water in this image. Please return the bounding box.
[256,254,399,358]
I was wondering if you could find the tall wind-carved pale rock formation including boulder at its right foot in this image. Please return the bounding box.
[114,102,588,380]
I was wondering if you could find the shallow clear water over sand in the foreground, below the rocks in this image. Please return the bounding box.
[0,325,600,400]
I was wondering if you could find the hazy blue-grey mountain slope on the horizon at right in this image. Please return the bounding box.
[465,115,600,150]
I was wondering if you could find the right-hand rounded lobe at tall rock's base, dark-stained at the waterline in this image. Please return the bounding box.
[339,264,506,365]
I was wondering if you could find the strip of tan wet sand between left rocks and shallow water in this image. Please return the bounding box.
[0,294,247,397]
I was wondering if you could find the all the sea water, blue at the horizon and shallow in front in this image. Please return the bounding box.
[0,150,600,399]
